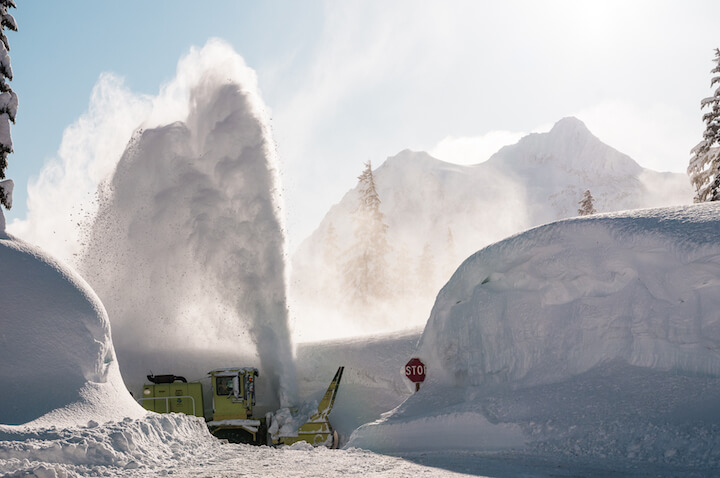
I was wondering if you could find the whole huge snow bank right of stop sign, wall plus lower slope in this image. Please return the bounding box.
[348,204,720,476]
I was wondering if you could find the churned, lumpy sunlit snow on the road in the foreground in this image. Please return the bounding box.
[0,415,484,478]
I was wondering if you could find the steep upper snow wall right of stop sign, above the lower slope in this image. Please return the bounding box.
[418,204,720,386]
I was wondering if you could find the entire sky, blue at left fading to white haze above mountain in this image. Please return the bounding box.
[6,0,720,250]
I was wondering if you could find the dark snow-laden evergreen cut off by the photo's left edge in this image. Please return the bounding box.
[0,0,18,209]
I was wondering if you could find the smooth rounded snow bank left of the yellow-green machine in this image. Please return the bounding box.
[0,220,145,426]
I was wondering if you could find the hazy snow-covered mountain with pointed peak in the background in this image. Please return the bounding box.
[291,118,693,338]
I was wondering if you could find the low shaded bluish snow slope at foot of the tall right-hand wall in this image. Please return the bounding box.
[347,361,720,477]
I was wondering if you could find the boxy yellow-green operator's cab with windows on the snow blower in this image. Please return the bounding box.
[209,367,258,421]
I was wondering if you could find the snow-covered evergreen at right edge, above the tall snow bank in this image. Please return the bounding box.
[687,48,720,202]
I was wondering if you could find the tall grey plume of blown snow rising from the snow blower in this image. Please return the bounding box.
[80,41,297,406]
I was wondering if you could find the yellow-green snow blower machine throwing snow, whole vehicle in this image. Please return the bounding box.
[139,367,344,448]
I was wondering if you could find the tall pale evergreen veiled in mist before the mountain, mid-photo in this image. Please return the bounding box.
[344,161,390,305]
